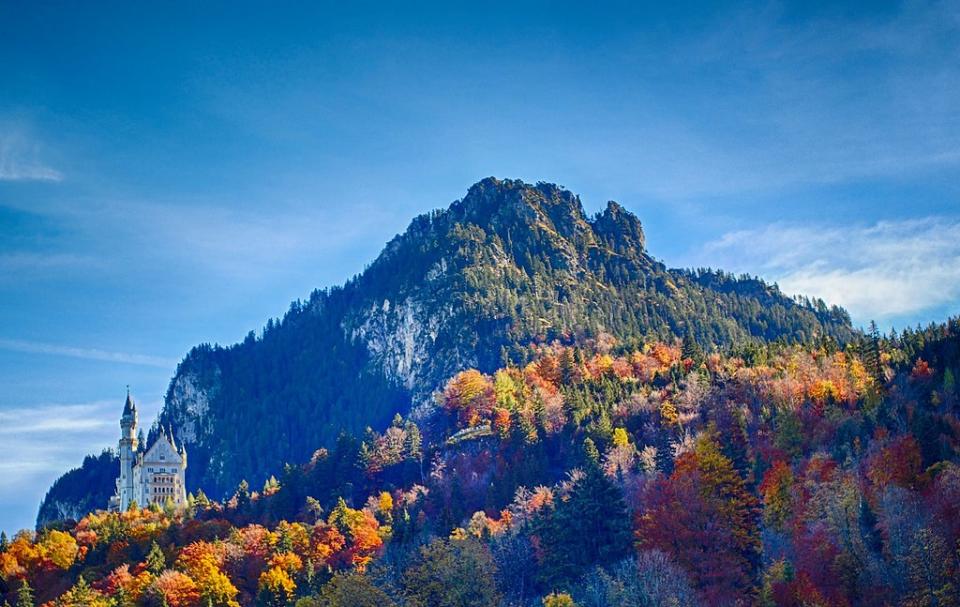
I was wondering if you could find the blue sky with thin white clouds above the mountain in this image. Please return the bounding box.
[0,2,960,530]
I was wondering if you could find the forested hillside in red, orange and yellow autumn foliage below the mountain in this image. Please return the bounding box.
[9,319,960,607]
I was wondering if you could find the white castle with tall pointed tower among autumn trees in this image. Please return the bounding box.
[109,390,187,512]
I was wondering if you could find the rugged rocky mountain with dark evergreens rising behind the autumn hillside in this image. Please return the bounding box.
[37,178,854,524]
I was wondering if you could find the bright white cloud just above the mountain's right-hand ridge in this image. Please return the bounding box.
[687,217,960,323]
